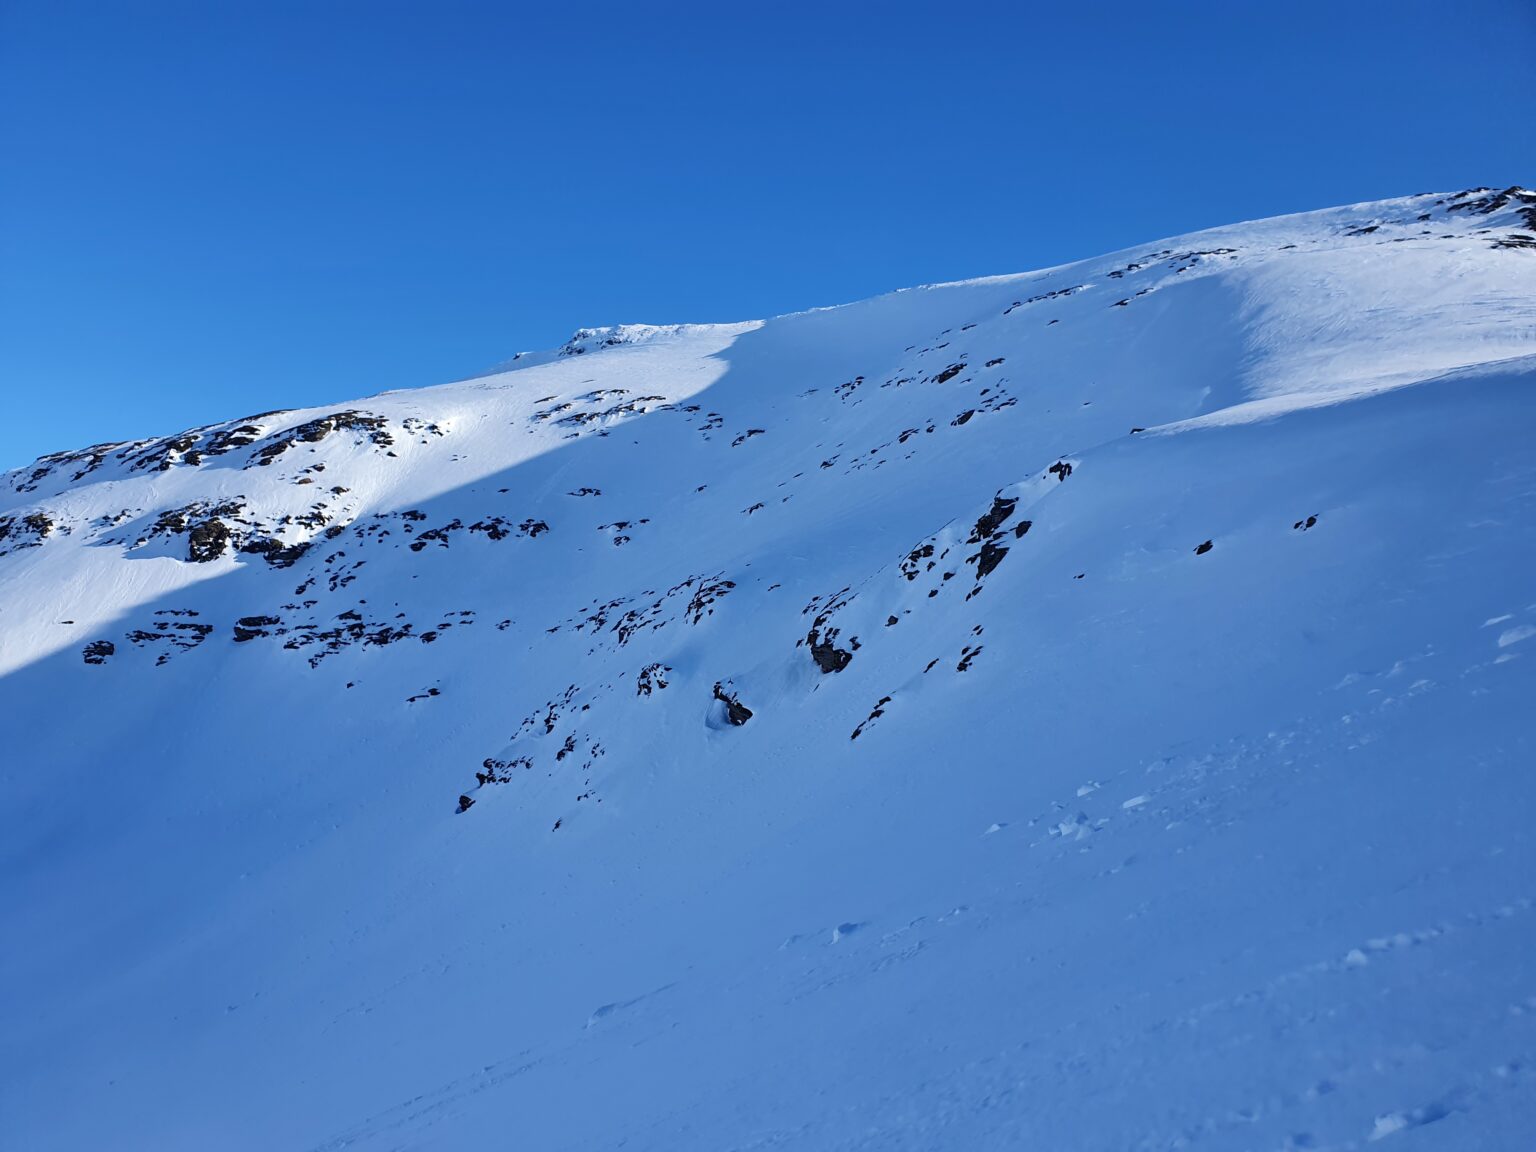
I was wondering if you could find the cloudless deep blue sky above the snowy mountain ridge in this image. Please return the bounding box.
[0,0,1536,467]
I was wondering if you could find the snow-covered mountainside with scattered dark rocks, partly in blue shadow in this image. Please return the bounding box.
[0,190,1536,1150]
